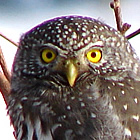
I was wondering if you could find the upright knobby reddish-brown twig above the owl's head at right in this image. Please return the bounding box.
[110,0,131,34]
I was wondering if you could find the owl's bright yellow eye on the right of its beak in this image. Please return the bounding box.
[87,49,102,63]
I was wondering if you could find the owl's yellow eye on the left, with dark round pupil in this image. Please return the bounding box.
[41,49,56,63]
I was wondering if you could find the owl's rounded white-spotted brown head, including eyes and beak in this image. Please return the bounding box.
[13,17,137,87]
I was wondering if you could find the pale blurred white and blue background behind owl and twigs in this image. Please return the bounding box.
[0,0,140,140]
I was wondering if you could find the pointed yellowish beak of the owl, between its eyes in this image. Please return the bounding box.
[66,60,78,87]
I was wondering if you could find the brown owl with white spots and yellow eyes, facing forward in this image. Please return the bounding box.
[8,16,140,140]
